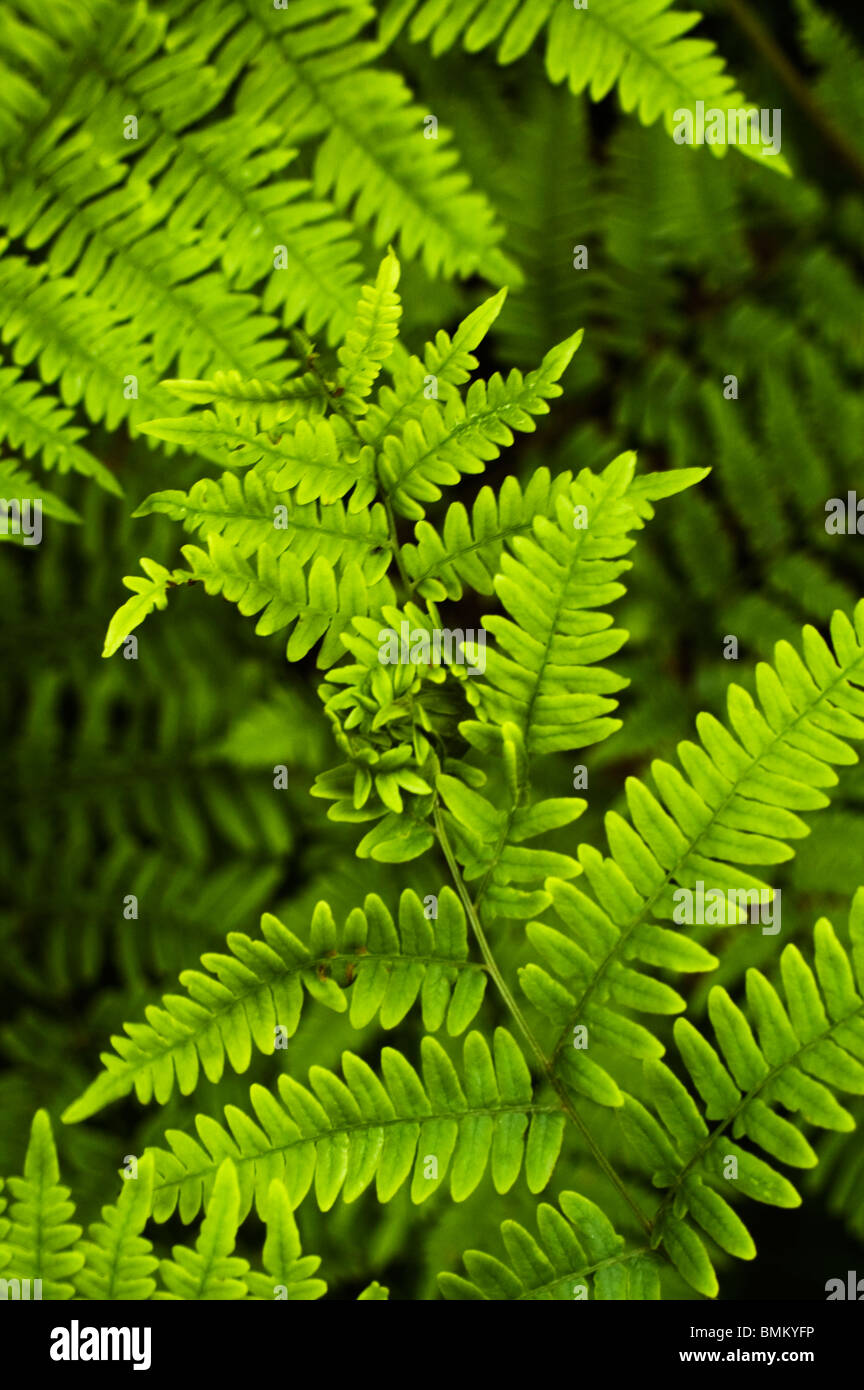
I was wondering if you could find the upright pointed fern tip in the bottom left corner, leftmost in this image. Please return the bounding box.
[3,1111,85,1300]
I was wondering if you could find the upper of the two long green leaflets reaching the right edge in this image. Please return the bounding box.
[521,602,864,1104]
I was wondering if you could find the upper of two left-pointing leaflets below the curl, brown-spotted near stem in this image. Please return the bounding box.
[63,888,486,1123]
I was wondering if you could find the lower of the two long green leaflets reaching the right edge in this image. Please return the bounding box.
[620,888,864,1297]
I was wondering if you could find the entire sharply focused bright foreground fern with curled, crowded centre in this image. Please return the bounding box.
[0,252,864,1300]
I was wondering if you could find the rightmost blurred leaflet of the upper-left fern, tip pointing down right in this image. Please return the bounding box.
[169,0,507,278]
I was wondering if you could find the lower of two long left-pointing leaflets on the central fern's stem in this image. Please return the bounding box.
[142,1029,564,1222]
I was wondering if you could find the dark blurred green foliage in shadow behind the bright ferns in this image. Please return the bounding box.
[0,0,864,1298]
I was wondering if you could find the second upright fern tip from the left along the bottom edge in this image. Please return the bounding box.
[75,1154,158,1300]
